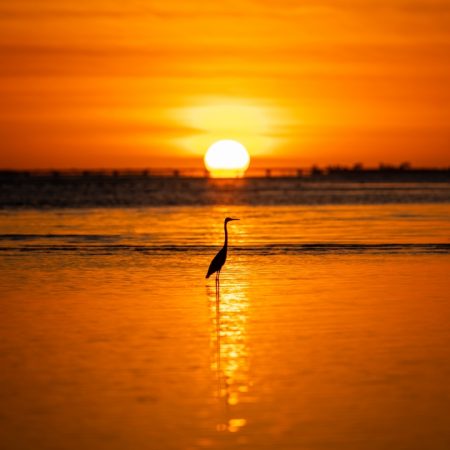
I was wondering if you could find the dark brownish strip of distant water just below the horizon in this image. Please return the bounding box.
[0,178,450,208]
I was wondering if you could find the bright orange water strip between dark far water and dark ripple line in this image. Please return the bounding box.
[0,203,450,251]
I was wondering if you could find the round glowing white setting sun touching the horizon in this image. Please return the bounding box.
[204,139,250,178]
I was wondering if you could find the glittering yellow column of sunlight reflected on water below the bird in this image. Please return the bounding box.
[208,283,249,432]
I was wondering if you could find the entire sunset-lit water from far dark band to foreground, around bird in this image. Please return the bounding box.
[0,179,450,450]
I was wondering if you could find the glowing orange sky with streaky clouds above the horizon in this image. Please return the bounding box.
[0,0,450,168]
